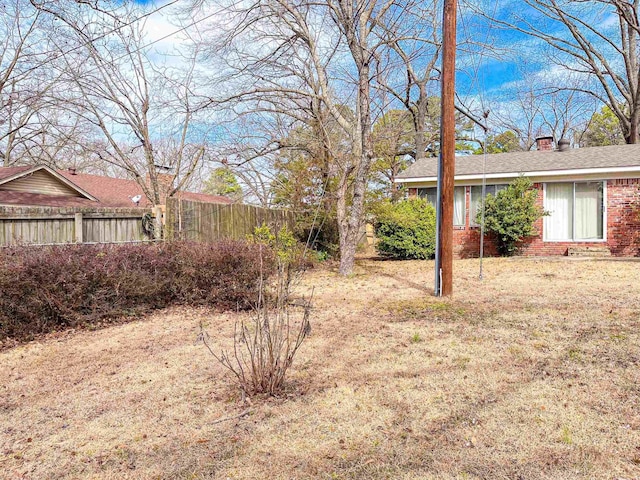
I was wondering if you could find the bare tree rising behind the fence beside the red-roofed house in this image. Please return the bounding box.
[40,5,206,204]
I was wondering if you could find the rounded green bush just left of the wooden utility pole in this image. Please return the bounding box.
[374,198,436,259]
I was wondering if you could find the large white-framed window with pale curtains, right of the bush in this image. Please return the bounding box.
[544,182,605,241]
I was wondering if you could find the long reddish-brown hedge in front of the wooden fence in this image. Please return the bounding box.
[0,240,275,347]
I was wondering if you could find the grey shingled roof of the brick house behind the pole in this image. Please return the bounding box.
[397,145,640,181]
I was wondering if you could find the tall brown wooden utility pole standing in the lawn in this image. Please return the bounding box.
[435,0,457,296]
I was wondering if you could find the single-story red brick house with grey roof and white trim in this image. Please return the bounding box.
[396,137,640,258]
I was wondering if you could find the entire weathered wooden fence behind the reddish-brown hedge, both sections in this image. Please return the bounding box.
[0,198,294,247]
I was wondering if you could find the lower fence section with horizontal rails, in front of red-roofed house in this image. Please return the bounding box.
[0,207,151,246]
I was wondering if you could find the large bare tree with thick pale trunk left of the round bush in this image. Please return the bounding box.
[201,0,416,275]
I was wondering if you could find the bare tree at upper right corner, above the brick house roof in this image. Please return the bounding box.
[476,0,640,143]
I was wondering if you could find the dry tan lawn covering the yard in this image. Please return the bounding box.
[0,258,640,480]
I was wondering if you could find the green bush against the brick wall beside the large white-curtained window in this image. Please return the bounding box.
[476,177,548,255]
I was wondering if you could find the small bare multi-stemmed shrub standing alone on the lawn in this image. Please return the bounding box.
[199,227,311,396]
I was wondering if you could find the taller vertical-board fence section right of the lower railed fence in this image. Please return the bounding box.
[165,198,294,242]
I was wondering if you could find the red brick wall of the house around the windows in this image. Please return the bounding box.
[453,178,640,258]
